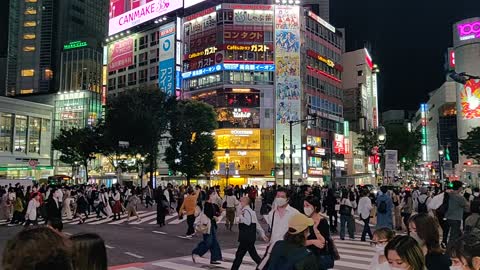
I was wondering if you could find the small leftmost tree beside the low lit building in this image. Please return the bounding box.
[52,126,100,181]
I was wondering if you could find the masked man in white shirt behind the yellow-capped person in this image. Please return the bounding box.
[258,188,300,269]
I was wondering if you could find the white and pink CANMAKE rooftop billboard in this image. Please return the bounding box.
[108,0,183,35]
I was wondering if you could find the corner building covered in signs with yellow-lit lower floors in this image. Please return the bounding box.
[182,3,345,185]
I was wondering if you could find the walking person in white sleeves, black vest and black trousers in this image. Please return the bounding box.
[232,197,268,270]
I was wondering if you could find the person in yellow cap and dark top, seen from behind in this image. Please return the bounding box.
[268,213,321,270]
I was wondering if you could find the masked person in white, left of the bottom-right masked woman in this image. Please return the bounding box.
[368,228,395,270]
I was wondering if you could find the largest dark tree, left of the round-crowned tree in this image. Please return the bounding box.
[103,86,175,182]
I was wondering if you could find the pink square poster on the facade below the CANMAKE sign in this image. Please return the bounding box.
[108,38,133,72]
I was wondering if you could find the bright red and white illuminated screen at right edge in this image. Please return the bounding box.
[460,80,480,119]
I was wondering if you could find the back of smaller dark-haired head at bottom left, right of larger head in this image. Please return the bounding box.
[70,233,108,270]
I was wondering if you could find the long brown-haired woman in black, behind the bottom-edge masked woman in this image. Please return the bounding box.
[408,213,452,270]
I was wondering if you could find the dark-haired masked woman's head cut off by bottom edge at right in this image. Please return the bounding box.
[384,235,425,270]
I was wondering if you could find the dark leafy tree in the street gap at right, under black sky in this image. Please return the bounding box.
[385,125,422,171]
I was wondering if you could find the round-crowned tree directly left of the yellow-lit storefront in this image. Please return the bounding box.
[164,100,217,185]
